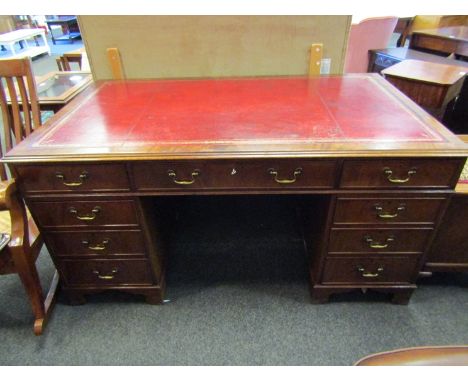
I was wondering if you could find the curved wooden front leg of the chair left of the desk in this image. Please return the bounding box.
[10,247,45,332]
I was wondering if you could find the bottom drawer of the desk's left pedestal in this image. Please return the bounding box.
[59,259,153,287]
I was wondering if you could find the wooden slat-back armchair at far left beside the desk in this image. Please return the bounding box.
[0,58,58,335]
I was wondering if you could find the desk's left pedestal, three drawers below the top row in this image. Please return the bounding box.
[36,196,165,304]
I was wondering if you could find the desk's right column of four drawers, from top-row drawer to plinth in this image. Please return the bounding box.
[310,158,463,304]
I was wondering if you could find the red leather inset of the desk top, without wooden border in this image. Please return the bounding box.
[39,77,441,146]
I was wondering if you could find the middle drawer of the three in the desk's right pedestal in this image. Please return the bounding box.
[328,228,433,254]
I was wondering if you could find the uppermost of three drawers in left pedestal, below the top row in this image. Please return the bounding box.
[30,200,138,228]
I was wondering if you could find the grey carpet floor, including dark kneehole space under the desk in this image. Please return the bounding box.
[0,197,468,365]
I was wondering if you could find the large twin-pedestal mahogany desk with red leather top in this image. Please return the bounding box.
[4,74,468,303]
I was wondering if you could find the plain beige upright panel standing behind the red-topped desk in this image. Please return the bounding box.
[79,16,351,79]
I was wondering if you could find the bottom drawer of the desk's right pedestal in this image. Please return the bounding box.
[322,257,418,284]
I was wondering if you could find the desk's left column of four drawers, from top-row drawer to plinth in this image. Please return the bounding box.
[18,163,165,304]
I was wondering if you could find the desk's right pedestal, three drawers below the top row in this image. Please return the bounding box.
[311,193,447,304]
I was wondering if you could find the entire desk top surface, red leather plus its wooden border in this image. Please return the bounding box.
[7,74,468,161]
